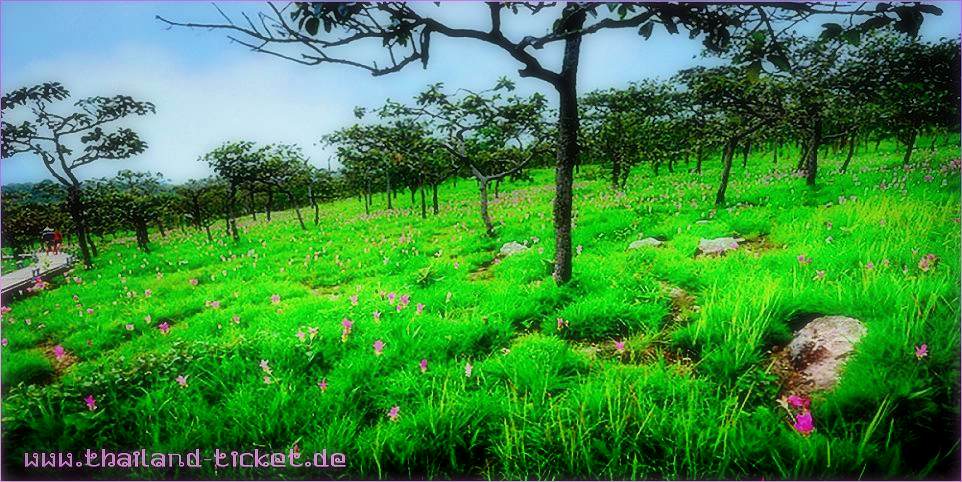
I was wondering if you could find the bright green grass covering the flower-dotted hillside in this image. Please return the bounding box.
[2,136,960,479]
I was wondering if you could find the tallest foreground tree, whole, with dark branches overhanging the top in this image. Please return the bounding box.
[157,2,941,284]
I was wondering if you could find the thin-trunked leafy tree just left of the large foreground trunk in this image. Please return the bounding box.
[380,79,547,237]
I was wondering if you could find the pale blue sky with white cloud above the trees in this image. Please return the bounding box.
[0,0,960,184]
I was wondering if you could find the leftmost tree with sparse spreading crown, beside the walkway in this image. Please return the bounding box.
[0,82,155,268]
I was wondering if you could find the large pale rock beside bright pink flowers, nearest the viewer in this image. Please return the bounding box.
[788,316,866,390]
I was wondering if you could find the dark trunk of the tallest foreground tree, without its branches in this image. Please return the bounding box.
[552,6,586,285]
